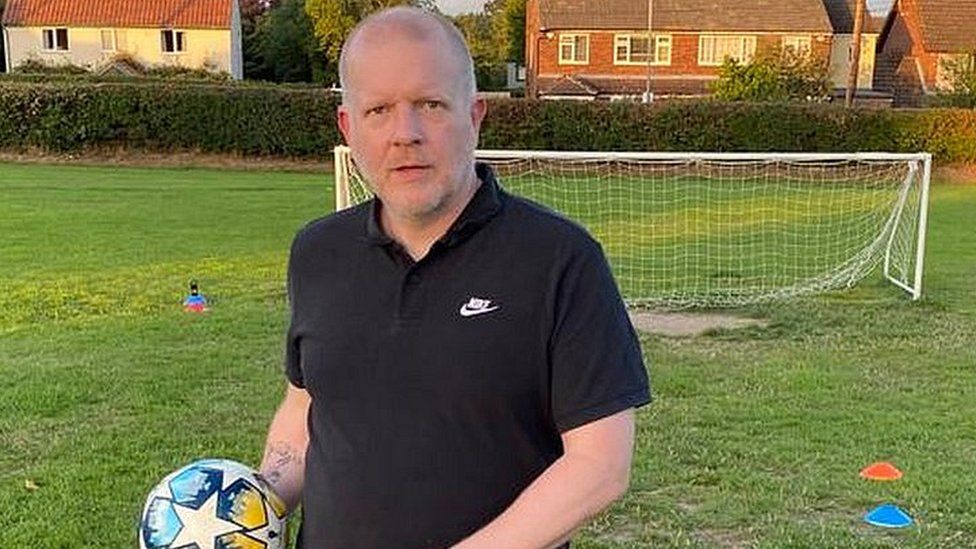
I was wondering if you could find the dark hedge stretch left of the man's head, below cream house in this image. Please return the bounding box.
[0,82,339,157]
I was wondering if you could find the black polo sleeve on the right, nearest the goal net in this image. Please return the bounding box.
[550,240,651,433]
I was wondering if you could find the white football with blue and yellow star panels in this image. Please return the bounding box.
[139,459,287,549]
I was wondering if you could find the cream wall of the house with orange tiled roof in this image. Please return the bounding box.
[7,27,232,73]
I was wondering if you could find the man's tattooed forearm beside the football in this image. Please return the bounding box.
[261,383,312,511]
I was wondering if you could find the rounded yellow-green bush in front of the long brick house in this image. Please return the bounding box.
[712,49,830,101]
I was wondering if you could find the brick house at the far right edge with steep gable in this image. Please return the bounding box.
[876,0,976,106]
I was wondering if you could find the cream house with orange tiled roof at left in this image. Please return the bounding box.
[2,0,244,79]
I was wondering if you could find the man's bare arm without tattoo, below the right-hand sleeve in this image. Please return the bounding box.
[455,408,634,549]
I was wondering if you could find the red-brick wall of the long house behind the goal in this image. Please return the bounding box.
[537,30,832,78]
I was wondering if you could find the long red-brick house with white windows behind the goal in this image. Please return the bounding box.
[525,0,892,99]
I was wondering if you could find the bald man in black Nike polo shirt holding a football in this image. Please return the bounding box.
[261,8,650,548]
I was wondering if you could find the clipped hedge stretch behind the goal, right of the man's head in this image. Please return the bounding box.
[481,100,976,162]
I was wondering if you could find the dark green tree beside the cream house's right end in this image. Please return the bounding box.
[245,0,335,82]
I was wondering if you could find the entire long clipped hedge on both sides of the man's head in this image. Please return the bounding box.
[0,80,976,163]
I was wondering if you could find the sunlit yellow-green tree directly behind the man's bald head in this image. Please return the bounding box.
[305,0,437,74]
